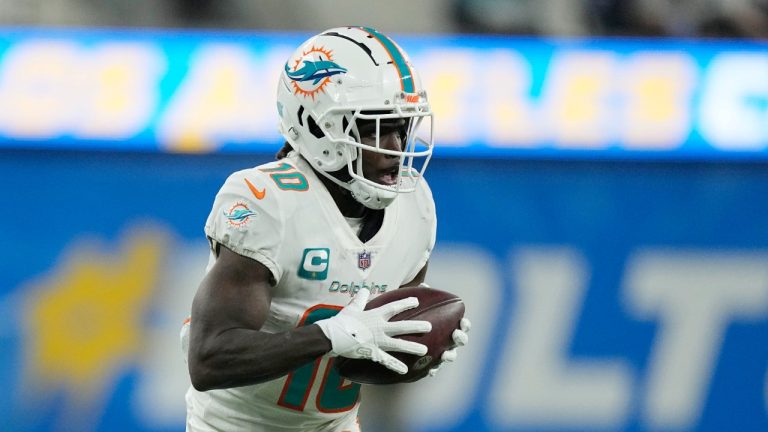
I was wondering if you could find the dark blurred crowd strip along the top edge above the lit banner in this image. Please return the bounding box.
[0,0,768,39]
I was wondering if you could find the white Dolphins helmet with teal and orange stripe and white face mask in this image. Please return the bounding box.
[277,27,434,209]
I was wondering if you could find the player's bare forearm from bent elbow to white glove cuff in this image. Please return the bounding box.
[189,325,331,391]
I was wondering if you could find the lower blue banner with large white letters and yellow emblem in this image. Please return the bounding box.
[0,150,768,432]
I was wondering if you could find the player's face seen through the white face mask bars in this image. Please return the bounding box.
[357,119,407,185]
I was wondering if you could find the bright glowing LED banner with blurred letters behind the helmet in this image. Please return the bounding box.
[0,28,768,160]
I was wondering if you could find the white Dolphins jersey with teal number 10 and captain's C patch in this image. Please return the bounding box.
[187,153,436,431]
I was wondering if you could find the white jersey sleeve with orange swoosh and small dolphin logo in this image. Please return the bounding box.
[205,169,285,281]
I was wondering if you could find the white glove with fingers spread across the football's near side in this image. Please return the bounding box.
[315,289,432,374]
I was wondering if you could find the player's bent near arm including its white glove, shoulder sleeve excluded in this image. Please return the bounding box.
[187,247,431,391]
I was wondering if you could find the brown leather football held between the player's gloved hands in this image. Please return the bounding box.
[334,287,464,384]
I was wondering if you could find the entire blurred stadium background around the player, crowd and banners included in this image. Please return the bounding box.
[0,0,768,432]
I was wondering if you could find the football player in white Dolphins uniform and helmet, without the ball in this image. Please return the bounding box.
[182,27,469,432]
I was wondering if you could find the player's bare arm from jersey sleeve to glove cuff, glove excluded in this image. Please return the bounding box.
[188,247,331,391]
